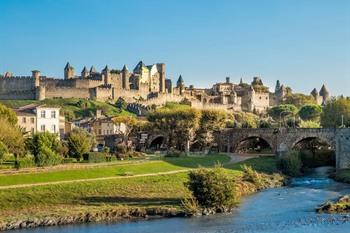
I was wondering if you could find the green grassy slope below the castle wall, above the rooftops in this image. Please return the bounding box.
[0,98,134,120]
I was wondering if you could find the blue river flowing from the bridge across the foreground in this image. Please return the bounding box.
[11,168,350,233]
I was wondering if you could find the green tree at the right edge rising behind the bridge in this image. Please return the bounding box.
[321,98,350,128]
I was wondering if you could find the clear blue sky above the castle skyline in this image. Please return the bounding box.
[0,0,350,96]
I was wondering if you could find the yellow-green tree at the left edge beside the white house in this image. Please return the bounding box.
[0,118,25,158]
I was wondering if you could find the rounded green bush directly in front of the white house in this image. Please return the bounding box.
[27,132,63,167]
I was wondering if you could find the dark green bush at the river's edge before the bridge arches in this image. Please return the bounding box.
[277,151,303,176]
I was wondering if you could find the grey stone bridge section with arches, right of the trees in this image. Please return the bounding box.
[218,128,350,168]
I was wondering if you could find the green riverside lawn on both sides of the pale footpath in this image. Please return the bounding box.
[0,155,275,222]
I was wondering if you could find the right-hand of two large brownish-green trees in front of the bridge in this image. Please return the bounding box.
[197,110,227,152]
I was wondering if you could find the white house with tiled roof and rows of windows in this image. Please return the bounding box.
[15,104,64,135]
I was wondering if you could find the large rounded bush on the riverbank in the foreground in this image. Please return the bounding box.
[186,167,238,209]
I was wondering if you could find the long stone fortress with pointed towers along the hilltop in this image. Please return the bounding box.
[0,61,330,113]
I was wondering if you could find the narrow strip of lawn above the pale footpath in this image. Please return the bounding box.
[0,155,230,186]
